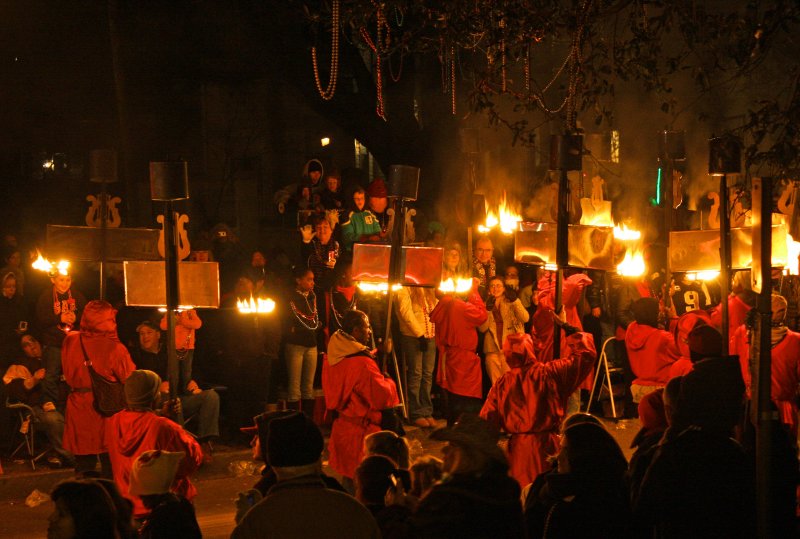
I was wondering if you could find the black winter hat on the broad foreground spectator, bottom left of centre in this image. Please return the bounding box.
[267,412,323,468]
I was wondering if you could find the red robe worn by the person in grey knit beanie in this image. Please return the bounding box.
[106,410,203,518]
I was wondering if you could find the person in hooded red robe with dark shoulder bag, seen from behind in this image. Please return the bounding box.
[61,300,136,478]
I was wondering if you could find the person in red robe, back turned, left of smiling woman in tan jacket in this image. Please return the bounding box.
[430,279,488,425]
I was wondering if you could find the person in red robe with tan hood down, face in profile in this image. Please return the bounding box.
[322,310,399,480]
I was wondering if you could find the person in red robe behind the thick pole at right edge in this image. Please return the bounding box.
[730,294,800,438]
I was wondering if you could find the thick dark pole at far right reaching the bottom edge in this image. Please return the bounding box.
[752,178,777,539]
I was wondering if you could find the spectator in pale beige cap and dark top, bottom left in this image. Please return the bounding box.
[128,450,202,539]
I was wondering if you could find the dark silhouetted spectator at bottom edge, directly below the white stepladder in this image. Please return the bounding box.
[525,423,631,538]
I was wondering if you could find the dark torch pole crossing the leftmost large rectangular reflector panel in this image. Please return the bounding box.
[164,200,183,425]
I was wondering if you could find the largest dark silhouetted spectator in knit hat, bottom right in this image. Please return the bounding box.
[634,357,755,538]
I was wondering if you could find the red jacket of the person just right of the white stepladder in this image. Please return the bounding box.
[625,322,680,386]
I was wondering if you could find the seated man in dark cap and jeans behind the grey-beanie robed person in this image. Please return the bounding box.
[131,320,219,461]
